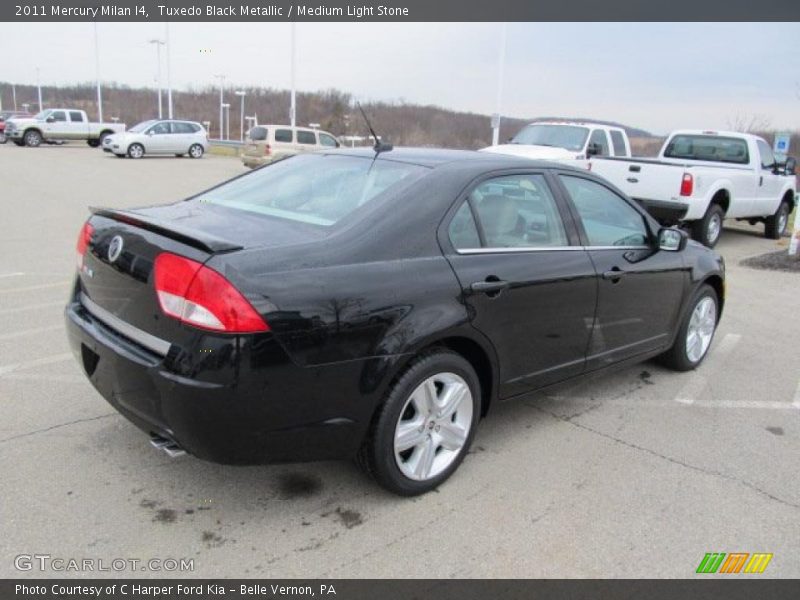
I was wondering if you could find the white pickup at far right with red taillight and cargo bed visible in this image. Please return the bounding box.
[589,130,796,247]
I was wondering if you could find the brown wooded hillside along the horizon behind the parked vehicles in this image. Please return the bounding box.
[0,82,650,148]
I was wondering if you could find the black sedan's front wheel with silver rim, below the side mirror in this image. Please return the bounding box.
[661,284,719,371]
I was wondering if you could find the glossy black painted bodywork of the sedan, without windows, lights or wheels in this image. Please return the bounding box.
[66,149,724,463]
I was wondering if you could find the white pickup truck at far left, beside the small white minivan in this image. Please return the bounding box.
[5,108,125,148]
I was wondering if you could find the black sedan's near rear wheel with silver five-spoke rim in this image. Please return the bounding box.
[357,350,481,496]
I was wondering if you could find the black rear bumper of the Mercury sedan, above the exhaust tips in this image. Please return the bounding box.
[66,300,376,464]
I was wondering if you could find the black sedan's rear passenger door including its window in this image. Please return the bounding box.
[441,171,597,397]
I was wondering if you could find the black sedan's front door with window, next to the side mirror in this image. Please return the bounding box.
[558,173,688,370]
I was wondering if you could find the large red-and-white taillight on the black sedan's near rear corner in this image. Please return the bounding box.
[155,252,269,333]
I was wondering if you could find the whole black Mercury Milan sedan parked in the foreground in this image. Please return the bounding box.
[66,149,725,495]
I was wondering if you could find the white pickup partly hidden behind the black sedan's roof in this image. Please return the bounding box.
[481,121,631,167]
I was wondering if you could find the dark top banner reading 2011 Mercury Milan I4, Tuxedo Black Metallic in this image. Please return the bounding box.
[0,0,800,22]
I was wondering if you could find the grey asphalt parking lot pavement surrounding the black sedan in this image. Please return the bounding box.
[0,144,800,578]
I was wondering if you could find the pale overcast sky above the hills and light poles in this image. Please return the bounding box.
[0,23,800,133]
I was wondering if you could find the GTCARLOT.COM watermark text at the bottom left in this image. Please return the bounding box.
[14,554,194,573]
